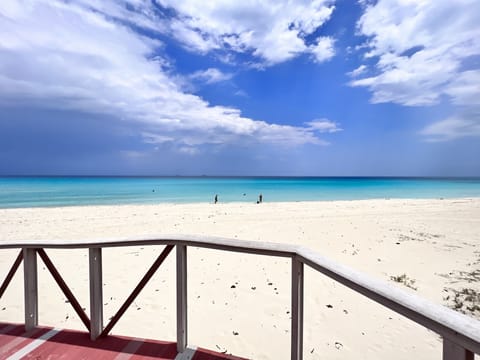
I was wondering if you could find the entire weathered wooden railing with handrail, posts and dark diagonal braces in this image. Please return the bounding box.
[0,235,480,360]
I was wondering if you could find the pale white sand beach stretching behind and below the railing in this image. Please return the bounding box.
[0,198,480,359]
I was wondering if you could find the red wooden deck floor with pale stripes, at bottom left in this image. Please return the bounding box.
[0,322,246,360]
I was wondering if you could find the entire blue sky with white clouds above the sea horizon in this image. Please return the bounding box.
[0,0,480,176]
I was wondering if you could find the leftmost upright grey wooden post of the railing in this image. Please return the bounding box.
[23,248,38,331]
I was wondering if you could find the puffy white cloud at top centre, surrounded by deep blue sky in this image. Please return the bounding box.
[157,0,334,65]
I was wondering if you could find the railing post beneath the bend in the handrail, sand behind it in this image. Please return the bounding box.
[291,256,303,360]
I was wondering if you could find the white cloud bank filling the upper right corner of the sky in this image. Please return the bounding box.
[351,0,480,139]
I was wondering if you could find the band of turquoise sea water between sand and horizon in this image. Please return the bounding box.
[0,177,480,208]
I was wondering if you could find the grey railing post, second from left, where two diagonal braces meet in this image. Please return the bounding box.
[88,248,103,340]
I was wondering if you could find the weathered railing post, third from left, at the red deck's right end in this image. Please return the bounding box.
[177,245,187,353]
